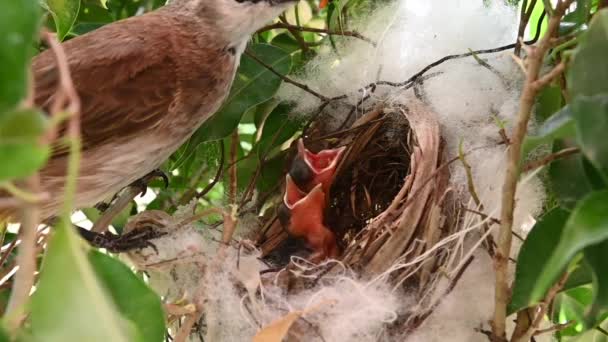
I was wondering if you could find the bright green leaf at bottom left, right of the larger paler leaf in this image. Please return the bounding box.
[89,251,165,342]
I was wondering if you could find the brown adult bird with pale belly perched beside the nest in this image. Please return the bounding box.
[0,0,297,221]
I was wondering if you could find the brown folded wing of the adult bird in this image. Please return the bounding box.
[32,13,177,157]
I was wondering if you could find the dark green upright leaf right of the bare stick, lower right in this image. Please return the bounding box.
[508,208,569,314]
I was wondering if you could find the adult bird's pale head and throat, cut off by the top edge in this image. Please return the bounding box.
[172,0,299,43]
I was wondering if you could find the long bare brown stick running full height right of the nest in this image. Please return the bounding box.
[492,0,573,340]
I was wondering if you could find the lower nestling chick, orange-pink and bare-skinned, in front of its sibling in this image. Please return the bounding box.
[279,175,338,261]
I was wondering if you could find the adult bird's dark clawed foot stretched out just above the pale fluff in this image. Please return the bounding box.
[78,227,167,254]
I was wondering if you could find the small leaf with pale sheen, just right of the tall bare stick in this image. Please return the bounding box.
[522,106,576,158]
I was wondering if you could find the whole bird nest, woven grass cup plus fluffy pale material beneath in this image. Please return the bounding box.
[125,96,472,341]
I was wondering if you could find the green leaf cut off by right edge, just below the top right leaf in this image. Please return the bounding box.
[572,94,608,179]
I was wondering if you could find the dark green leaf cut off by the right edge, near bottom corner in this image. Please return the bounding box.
[584,240,608,327]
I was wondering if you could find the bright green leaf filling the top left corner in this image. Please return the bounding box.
[0,0,40,115]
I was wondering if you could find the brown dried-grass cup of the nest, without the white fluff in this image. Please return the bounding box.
[258,96,472,331]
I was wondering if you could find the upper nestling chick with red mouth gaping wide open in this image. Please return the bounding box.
[289,139,346,194]
